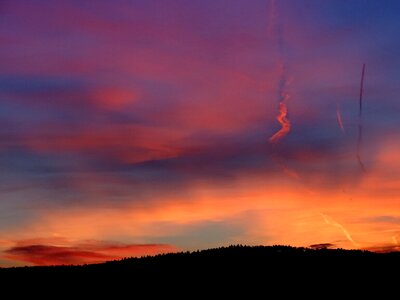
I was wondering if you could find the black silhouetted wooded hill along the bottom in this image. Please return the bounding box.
[0,246,400,298]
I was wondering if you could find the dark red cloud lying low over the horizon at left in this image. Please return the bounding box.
[3,239,177,266]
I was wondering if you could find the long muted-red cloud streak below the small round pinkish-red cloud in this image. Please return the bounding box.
[25,125,186,163]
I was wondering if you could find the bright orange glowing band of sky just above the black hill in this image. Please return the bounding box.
[2,145,400,264]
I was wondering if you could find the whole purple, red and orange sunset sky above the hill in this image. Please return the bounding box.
[0,0,400,267]
